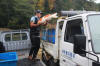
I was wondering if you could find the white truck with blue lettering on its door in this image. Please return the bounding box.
[42,11,100,66]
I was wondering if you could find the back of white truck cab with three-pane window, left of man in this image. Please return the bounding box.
[0,29,31,56]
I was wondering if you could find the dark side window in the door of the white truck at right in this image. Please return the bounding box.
[64,19,84,43]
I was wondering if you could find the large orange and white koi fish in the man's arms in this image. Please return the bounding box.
[38,13,58,23]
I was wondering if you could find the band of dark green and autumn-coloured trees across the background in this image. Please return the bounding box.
[0,0,100,29]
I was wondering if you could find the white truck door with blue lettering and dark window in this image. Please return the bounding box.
[60,18,88,66]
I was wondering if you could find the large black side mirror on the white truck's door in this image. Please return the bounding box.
[73,35,86,56]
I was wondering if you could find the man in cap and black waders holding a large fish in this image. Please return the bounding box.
[28,10,46,61]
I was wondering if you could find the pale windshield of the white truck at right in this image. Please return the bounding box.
[88,14,100,53]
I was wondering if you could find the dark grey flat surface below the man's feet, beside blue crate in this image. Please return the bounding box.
[17,58,45,66]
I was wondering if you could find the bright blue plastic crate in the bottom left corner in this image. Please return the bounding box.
[0,52,18,66]
